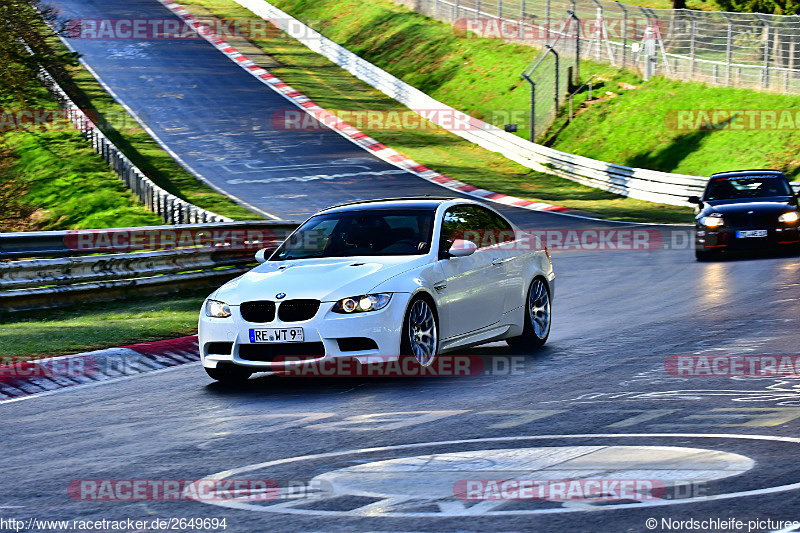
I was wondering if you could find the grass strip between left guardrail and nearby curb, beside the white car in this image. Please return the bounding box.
[0,290,209,358]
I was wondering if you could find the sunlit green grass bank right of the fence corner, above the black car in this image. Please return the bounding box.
[550,69,800,178]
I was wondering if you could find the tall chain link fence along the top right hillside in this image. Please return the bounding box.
[395,0,800,138]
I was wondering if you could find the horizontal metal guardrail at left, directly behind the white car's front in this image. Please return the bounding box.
[0,221,297,311]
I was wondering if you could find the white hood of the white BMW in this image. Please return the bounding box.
[213,255,431,305]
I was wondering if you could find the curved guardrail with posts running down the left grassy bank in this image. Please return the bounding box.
[39,65,232,224]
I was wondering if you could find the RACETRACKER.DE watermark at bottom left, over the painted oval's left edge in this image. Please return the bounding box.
[67,479,333,502]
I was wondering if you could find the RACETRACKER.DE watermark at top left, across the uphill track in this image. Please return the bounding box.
[65,18,320,41]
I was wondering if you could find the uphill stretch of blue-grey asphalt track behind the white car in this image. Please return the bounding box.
[48,0,592,223]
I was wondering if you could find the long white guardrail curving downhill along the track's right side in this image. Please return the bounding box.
[236,0,707,206]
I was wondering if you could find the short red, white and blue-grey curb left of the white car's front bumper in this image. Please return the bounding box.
[0,335,200,403]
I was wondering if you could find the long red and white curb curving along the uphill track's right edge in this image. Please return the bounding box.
[153,0,574,213]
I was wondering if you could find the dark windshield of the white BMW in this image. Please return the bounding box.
[270,209,434,261]
